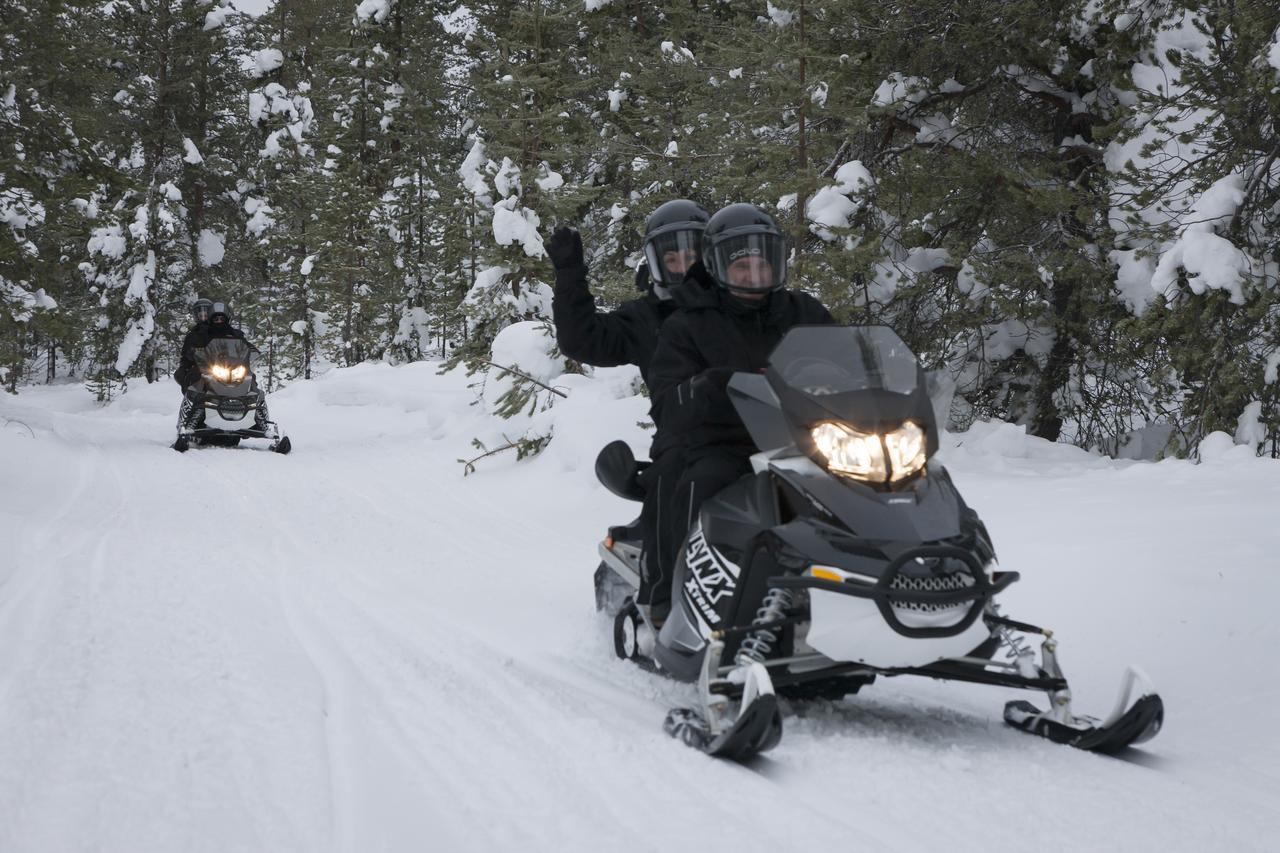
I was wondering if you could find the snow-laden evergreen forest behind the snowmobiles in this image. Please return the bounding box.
[0,0,1280,457]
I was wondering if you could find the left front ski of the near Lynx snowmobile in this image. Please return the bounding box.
[662,640,782,761]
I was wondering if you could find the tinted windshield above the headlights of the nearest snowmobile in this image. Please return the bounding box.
[769,325,919,398]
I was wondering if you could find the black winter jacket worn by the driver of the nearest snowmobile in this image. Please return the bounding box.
[649,272,835,455]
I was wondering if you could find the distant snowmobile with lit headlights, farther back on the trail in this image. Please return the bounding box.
[173,338,292,453]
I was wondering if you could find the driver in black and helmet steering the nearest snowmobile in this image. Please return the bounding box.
[649,204,835,610]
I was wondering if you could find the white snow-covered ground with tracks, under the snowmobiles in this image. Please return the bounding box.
[0,365,1280,853]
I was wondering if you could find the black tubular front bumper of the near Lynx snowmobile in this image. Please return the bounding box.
[768,546,1020,637]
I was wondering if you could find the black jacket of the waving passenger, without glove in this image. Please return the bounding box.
[552,266,675,384]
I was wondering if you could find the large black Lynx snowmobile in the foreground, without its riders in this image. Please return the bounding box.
[595,325,1164,761]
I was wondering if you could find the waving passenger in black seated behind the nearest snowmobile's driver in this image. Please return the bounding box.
[547,199,710,605]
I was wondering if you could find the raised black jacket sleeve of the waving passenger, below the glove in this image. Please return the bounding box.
[552,266,639,368]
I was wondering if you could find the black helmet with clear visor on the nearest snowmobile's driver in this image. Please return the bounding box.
[703,202,787,296]
